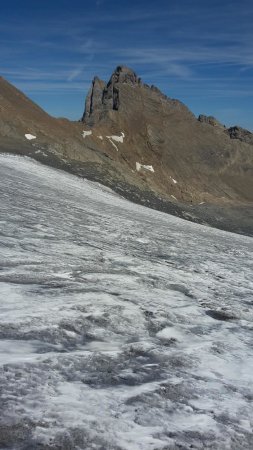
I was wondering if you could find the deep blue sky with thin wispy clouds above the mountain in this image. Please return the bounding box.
[0,0,253,131]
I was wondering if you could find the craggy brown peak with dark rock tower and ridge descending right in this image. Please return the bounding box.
[82,66,253,201]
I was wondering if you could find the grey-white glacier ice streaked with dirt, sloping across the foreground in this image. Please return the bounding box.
[0,156,253,450]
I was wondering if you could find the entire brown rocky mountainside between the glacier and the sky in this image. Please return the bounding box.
[0,66,253,232]
